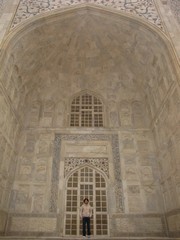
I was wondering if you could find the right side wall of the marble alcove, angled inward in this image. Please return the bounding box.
[153,85,180,232]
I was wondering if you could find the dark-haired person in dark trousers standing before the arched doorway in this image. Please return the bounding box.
[80,198,92,238]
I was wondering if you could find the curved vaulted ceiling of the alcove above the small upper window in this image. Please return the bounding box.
[1,7,179,124]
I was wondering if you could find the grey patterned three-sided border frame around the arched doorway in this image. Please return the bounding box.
[49,134,124,213]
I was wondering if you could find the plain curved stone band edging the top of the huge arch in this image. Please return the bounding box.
[0,4,180,87]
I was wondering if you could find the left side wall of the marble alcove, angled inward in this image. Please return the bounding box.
[0,86,20,232]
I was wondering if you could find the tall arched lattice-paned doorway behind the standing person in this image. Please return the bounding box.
[64,165,108,236]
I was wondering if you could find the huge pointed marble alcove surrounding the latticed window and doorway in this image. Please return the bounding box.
[0,5,180,237]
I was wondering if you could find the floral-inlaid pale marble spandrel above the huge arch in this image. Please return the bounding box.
[11,0,163,29]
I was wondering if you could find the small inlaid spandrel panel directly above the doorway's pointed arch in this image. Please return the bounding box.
[64,157,109,177]
